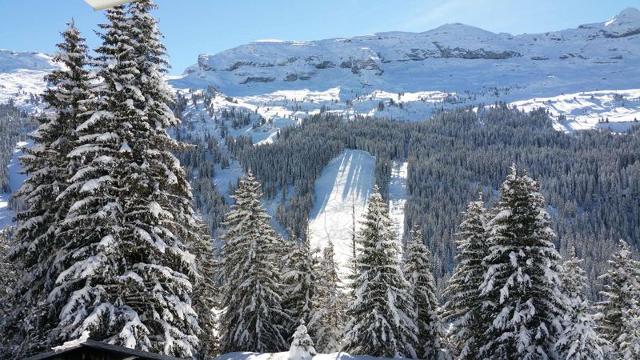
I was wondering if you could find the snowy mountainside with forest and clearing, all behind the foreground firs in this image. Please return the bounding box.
[0,3,640,316]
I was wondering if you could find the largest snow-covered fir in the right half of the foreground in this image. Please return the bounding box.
[481,165,564,360]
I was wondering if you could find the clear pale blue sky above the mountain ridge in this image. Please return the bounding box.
[0,0,640,73]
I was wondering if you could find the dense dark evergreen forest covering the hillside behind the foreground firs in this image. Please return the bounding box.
[226,105,640,295]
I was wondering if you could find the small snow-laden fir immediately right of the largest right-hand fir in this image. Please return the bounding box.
[556,247,604,360]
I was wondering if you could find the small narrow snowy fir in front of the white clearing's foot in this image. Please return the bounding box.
[309,241,347,354]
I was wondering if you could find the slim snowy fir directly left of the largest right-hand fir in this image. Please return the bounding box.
[442,195,489,359]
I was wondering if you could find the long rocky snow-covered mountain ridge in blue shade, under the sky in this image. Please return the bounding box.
[178,9,640,100]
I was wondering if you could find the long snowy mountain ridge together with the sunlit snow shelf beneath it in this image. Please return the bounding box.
[172,8,640,131]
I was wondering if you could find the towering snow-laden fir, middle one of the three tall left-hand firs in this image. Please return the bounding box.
[48,6,150,350]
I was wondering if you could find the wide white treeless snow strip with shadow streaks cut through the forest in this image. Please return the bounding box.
[309,150,376,281]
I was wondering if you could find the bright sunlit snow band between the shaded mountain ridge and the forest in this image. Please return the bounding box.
[191,88,640,134]
